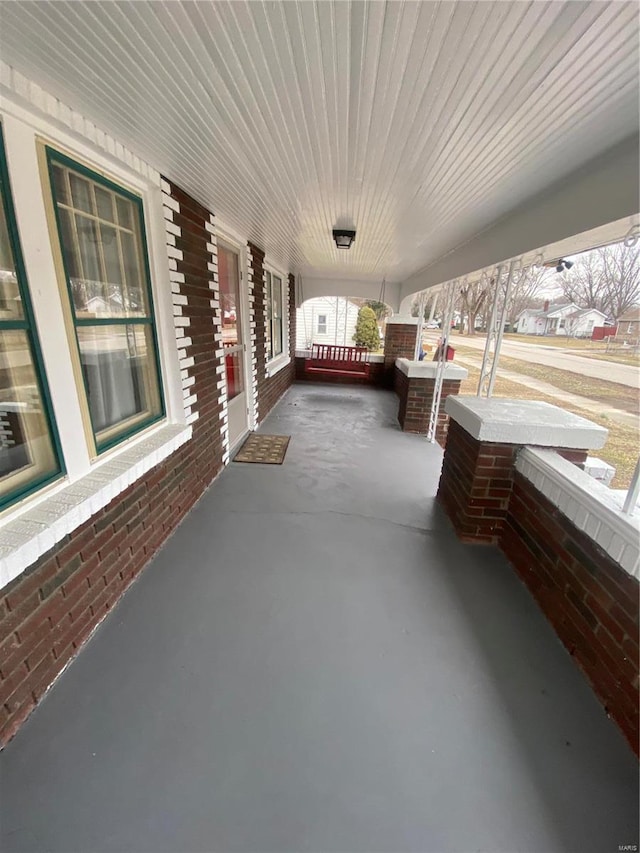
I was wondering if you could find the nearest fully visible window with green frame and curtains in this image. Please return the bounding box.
[46,148,164,453]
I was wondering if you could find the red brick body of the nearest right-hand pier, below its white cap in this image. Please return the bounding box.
[438,421,587,545]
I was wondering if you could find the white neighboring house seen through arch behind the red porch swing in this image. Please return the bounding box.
[296,296,360,349]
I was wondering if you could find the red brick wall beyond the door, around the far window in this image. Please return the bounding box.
[248,243,296,423]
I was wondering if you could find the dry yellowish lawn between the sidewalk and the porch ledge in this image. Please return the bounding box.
[460,364,639,489]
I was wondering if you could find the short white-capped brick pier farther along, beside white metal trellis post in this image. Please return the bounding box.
[394,358,469,447]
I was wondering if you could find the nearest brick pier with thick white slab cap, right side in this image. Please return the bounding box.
[438,396,608,544]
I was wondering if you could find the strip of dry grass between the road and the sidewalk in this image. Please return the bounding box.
[457,347,640,415]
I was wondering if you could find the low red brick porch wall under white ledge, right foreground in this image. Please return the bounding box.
[501,472,640,753]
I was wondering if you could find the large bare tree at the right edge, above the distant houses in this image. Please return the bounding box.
[561,243,640,319]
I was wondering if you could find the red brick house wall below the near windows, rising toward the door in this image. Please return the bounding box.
[0,180,222,743]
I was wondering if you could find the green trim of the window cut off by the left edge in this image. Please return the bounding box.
[0,123,66,511]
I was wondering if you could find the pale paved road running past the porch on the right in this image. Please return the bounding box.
[438,335,640,389]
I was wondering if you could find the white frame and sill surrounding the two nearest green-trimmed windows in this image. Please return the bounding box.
[0,94,192,588]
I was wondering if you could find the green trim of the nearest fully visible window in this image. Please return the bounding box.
[45,146,166,455]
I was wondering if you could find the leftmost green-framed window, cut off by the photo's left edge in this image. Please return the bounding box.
[0,127,62,508]
